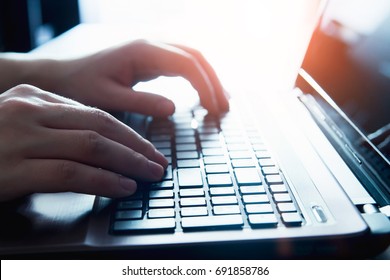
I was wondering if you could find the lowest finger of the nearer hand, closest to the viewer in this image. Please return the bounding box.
[15,159,137,197]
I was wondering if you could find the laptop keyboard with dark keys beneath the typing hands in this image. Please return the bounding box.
[110,108,304,234]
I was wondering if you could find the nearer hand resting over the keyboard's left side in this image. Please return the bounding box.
[0,85,168,201]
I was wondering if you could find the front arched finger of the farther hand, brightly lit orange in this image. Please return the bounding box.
[129,42,219,114]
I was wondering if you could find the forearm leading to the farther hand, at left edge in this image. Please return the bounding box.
[0,53,63,93]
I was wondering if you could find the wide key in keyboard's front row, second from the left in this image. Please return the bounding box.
[181,215,244,230]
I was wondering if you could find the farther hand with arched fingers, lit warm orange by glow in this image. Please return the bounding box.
[53,41,229,117]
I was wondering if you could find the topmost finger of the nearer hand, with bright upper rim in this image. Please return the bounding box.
[40,104,168,168]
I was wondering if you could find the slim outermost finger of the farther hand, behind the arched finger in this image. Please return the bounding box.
[173,44,229,112]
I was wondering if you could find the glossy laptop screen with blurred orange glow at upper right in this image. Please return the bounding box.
[303,0,390,159]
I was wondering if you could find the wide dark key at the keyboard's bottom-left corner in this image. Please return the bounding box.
[113,218,176,233]
